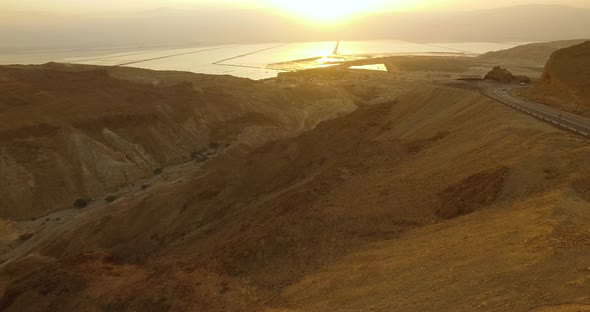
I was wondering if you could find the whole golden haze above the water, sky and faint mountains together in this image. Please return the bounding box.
[0,0,590,52]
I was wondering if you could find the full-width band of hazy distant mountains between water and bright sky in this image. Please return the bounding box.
[0,5,590,52]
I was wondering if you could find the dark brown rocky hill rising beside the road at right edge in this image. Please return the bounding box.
[522,41,590,116]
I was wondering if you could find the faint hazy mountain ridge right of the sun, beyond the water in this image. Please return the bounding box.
[359,5,590,42]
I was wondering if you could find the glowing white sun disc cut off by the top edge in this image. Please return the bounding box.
[270,0,387,23]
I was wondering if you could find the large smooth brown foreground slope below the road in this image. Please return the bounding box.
[0,72,590,312]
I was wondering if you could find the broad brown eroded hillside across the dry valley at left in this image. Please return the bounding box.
[0,64,356,219]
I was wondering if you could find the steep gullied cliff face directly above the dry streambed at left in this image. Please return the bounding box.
[0,119,208,219]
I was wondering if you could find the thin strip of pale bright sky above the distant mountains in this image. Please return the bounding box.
[0,0,590,25]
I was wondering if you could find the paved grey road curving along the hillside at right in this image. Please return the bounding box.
[482,83,590,137]
